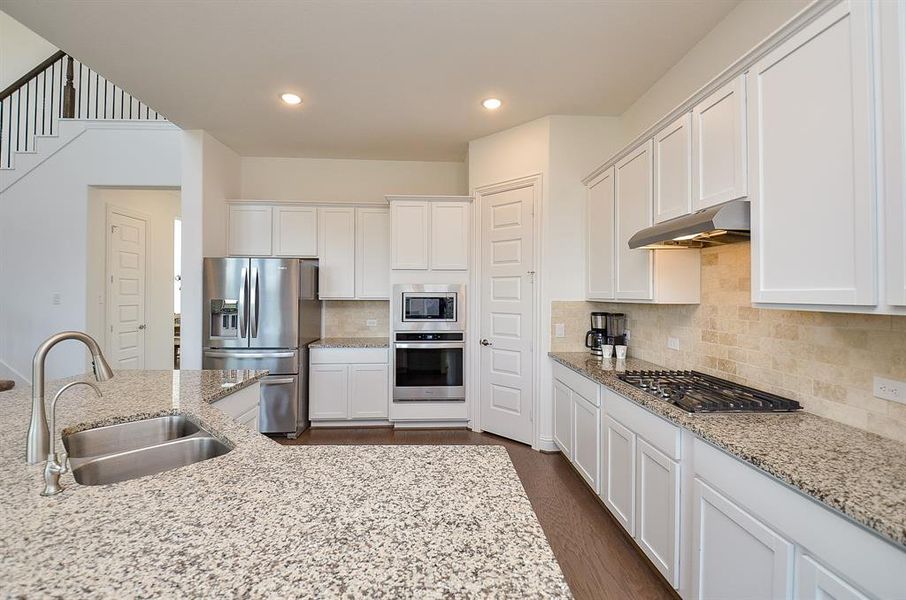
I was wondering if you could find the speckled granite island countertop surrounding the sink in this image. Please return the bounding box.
[0,371,570,598]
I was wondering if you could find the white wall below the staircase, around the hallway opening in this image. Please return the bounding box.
[0,121,181,381]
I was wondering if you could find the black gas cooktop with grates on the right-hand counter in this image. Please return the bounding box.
[618,371,802,413]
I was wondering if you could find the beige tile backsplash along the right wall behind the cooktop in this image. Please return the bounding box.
[551,244,906,442]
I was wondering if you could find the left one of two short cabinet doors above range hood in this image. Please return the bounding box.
[654,114,692,223]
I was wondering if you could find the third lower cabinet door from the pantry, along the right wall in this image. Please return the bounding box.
[601,415,635,536]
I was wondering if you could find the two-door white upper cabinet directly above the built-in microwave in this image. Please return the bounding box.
[387,196,471,271]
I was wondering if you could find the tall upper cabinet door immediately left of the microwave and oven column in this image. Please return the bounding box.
[355,208,390,300]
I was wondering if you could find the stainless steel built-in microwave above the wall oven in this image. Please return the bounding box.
[392,284,466,331]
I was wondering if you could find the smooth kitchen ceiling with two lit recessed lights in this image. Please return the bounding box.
[3,0,737,160]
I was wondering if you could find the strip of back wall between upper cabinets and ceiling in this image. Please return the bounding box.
[234,157,468,203]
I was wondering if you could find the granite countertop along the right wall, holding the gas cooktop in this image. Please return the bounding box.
[549,352,906,545]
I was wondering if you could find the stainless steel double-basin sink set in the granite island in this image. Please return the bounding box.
[63,415,230,485]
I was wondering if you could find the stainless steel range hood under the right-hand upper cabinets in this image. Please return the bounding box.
[629,200,750,248]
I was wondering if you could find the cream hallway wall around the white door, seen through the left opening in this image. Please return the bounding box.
[85,187,180,369]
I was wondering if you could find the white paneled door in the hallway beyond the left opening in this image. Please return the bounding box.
[106,208,148,369]
